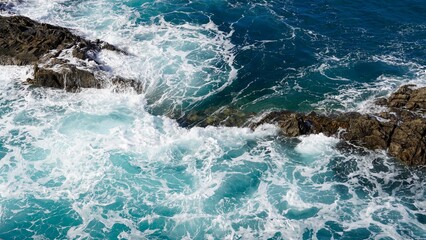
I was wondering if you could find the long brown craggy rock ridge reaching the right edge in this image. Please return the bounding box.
[251,85,426,165]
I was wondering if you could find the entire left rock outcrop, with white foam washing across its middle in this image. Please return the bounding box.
[0,16,142,93]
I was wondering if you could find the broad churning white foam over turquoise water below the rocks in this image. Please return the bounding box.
[0,67,425,239]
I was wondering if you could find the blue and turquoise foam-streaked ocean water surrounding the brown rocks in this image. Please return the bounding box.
[0,0,426,240]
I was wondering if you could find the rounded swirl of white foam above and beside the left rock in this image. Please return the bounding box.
[15,0,237,112]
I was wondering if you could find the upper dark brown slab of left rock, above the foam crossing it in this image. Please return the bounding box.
[0,16,124,65]
